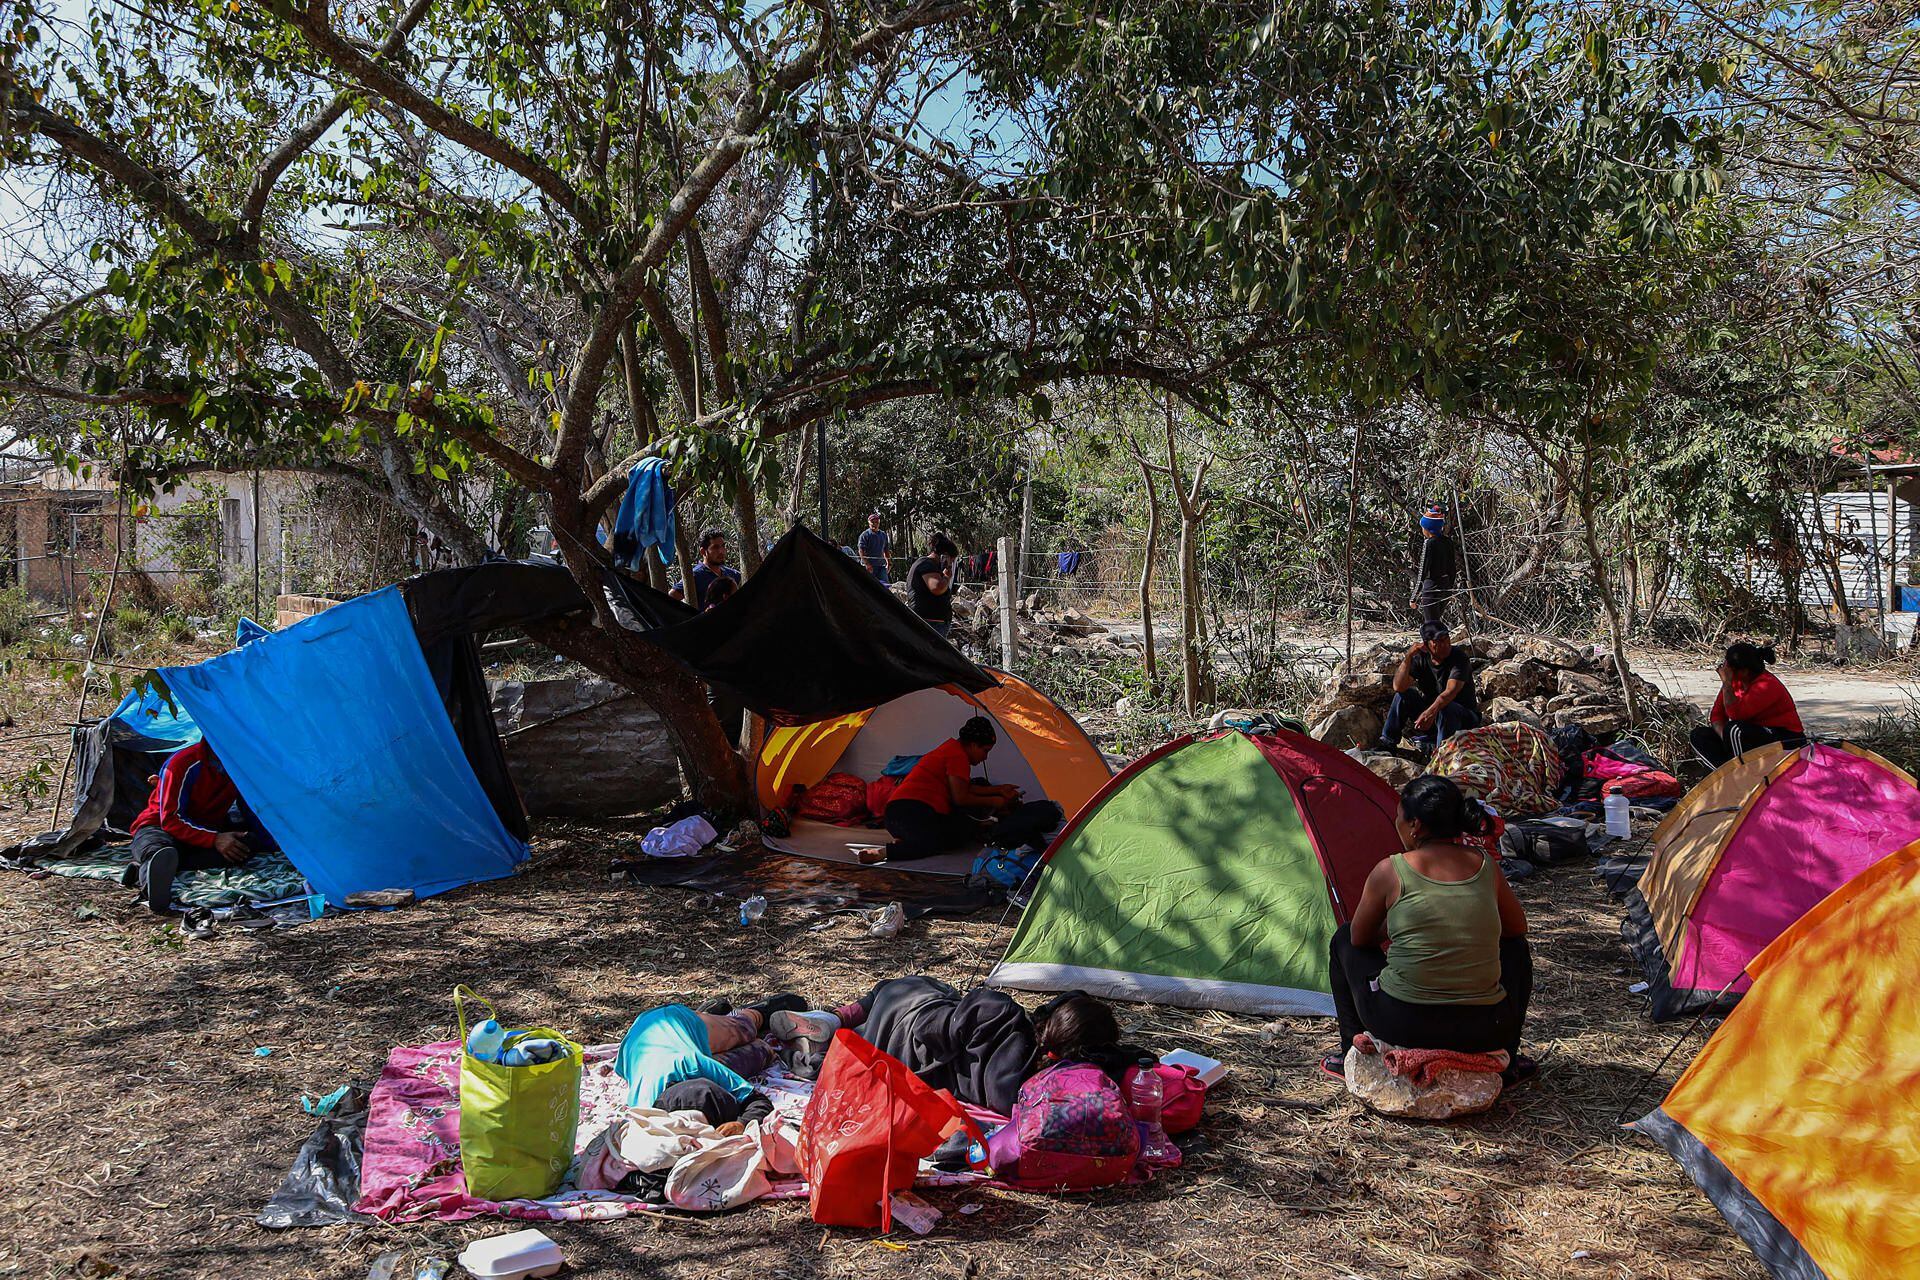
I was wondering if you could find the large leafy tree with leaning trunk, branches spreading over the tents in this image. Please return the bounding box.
[0,0,1715,804]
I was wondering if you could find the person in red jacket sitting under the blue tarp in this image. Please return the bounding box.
[132,741,269,915]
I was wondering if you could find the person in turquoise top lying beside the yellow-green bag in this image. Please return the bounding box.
[614,994,806,1136]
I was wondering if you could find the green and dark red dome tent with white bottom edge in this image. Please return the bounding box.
[987,729,1400,1015]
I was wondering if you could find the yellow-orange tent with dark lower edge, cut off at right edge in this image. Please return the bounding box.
[1634,841,1920,1280]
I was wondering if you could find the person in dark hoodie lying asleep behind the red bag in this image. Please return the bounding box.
[768,975,1146,1115]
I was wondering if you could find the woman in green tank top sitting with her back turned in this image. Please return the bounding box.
[1321,775,1534,1082]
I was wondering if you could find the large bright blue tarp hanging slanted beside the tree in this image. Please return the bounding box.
[161,587,526,906]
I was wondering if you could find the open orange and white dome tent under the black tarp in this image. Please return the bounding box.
[753,670,1114,873]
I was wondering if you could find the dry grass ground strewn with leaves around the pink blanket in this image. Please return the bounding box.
[0,809,1763,1280]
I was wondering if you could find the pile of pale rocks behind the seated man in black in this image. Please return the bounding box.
[1308,635,1699,748]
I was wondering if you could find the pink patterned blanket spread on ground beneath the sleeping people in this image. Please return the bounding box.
[353,1040,1004,1222]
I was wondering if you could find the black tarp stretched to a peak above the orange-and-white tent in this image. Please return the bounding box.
[641,528,995,723]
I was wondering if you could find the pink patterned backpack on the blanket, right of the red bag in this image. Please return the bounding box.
[987,1063,1140,1192]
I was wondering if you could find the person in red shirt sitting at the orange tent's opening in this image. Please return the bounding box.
[881,716,1066,862]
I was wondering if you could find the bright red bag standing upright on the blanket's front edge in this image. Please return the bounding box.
[799,1031,985,1230]
